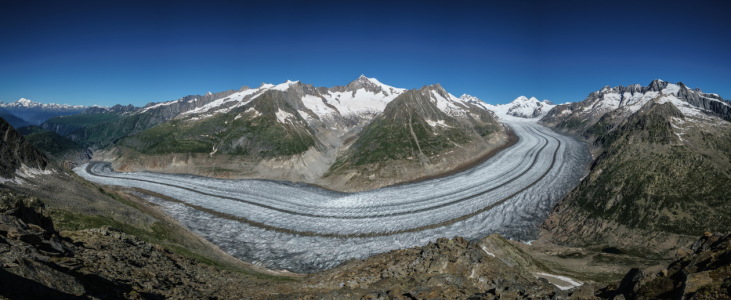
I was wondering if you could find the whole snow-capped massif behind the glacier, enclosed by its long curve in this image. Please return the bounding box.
[96,76,507,190]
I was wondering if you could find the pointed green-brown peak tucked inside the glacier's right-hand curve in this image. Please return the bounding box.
[326,85,505,189]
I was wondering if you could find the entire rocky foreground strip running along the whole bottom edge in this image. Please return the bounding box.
[0,186,731,299]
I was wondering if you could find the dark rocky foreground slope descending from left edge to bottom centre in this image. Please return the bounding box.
[0,190,288,299]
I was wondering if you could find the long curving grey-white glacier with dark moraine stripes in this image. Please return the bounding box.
[75,121,589,272]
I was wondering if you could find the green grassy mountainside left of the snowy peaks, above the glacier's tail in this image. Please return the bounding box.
[119,96,315,158]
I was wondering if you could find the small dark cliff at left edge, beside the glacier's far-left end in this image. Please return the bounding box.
[0,118,48,178]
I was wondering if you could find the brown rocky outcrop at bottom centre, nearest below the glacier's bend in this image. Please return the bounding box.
[284,235,592,299]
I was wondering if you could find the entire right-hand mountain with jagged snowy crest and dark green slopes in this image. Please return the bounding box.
[542,81,731,254]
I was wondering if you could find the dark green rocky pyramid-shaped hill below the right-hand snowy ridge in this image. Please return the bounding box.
[569,104,731,235]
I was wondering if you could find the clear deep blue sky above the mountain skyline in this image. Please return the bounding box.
[0,0,731,106]
